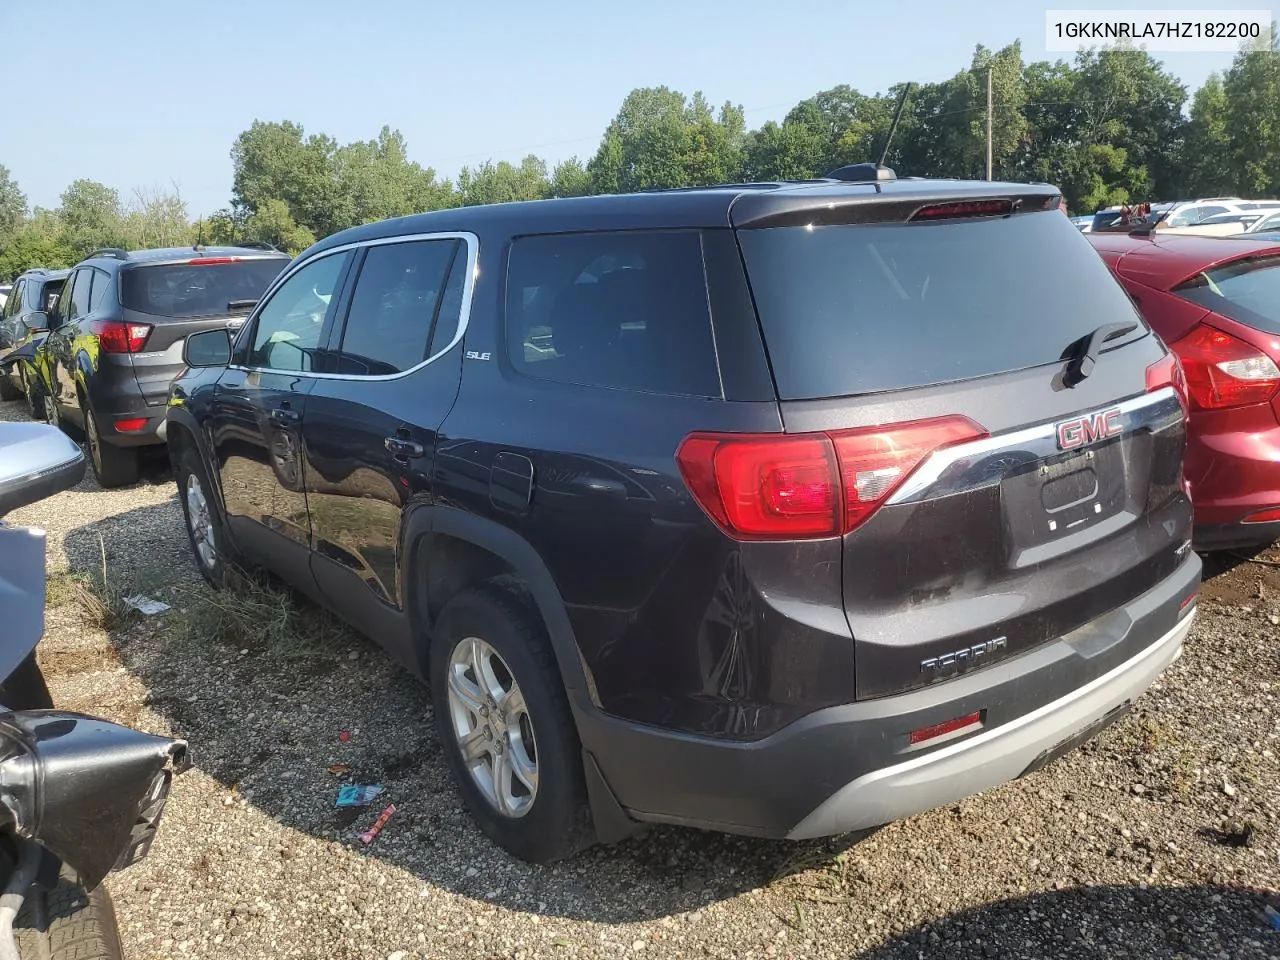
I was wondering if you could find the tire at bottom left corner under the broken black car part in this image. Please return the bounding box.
[14,869,124,960]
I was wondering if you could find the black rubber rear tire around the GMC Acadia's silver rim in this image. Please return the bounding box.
[430,585,595,864]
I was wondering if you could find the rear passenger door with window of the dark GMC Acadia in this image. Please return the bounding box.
[302,234,476,669]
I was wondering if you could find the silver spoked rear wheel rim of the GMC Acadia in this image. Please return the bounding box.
[448,636,538,818]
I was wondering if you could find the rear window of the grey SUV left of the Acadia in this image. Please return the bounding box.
[120,257,289,317]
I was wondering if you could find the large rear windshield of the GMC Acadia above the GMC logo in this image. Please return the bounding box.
[739,212,1147,399]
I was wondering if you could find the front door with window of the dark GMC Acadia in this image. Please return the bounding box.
[210,251,351,591]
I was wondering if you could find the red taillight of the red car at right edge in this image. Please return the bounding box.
[1170,326,1280,410]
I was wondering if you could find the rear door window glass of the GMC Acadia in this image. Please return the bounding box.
[338,239,467,376]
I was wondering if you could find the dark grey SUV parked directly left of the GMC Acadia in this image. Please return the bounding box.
[41,247,289,488]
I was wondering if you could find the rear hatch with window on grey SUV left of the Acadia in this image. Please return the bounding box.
[120,255,289,406]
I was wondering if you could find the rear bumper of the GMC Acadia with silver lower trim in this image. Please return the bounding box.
[579,554,1201,840]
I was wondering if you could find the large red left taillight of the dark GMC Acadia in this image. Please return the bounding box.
[676,416,987,540]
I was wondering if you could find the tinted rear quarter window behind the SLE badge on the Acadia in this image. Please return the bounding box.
[507,232,722,397]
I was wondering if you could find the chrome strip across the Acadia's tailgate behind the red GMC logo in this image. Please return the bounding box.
[886,387,1185,504]
